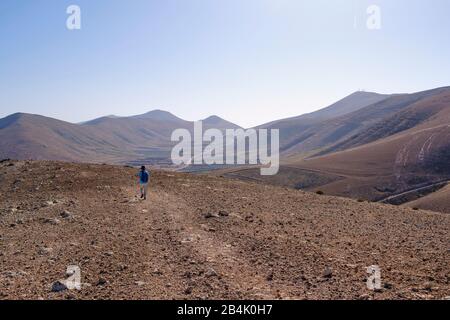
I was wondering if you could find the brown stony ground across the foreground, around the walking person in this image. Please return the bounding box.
[0,161,450,299]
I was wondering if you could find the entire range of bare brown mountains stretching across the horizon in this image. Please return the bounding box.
[0,87,450,210]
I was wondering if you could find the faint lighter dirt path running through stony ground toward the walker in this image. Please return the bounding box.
[130,189,276,299]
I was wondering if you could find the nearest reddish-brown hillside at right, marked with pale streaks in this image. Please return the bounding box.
[289,89,450,200]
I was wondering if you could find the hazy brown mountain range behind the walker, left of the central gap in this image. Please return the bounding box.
[0,110,238,165]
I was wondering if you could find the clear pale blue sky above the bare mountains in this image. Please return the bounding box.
[0,0,450,127]
